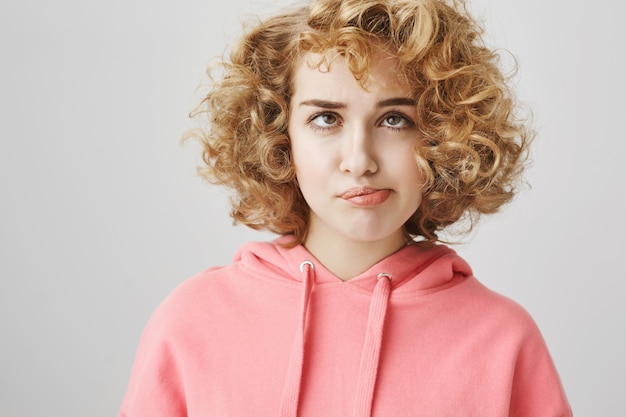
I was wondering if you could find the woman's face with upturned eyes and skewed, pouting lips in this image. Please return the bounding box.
[289,48,422,248]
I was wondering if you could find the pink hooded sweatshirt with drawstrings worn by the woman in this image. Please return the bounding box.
[119,238,572,417]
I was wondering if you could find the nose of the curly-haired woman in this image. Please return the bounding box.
[339,127,378,176]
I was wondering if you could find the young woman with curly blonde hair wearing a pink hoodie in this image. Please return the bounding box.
[120,0,571,417]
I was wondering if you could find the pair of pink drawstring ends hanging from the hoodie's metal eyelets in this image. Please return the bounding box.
[279,261,391,417]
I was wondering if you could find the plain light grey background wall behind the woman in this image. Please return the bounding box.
[0,0,626,417]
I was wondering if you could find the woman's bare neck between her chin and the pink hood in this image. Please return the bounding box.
[304,229,406,281]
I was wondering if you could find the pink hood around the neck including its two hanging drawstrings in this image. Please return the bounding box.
[233,236,472,417]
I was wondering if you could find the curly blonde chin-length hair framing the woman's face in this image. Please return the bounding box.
[188,0,531,245]
